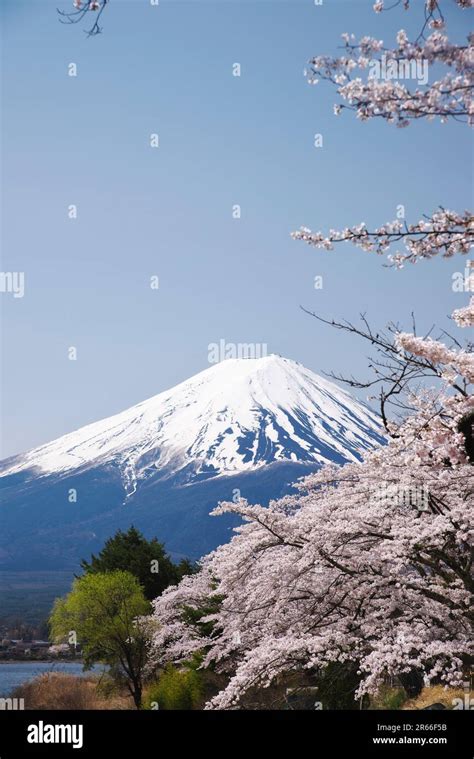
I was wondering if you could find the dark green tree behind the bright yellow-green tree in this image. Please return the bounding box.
[81,526,194,601]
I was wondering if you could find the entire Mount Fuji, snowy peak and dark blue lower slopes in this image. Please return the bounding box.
[0,355,384,570]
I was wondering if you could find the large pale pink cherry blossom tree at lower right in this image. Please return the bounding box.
[147,321,474,708]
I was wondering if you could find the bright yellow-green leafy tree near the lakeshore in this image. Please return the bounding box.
[50,570,152,709]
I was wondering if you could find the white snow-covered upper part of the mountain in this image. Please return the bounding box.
[0,355,381,495]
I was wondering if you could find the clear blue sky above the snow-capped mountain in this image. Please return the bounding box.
[0,0,472,456]
